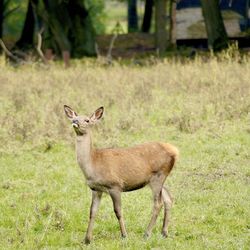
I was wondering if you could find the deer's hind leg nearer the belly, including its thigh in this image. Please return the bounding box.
[145,173,166,237]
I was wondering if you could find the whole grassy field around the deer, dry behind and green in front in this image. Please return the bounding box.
[0,56,250,250]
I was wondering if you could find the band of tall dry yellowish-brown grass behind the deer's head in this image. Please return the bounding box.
[0,55,250,151]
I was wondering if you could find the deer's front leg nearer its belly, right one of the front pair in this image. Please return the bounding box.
[109,189,127,238]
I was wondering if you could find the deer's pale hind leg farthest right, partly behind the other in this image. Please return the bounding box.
[161,187,173,237]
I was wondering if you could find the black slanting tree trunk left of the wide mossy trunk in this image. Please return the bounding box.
[16,0,38,49]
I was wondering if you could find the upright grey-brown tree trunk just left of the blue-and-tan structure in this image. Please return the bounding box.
[155,0,168,55]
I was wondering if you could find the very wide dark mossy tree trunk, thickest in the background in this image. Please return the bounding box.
[41,0,96,58]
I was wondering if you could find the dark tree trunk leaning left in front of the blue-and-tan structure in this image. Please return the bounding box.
[201,0,228,51]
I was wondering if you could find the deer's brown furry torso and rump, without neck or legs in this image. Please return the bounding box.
[92,142,178,191]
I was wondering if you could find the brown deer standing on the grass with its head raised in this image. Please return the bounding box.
[64,105,179,244]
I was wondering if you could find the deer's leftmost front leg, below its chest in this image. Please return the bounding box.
[85,191,102,244]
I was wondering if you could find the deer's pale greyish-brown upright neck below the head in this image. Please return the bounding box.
[76,132,93,179]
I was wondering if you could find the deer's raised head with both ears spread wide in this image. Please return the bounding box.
[64,105,104,135]
